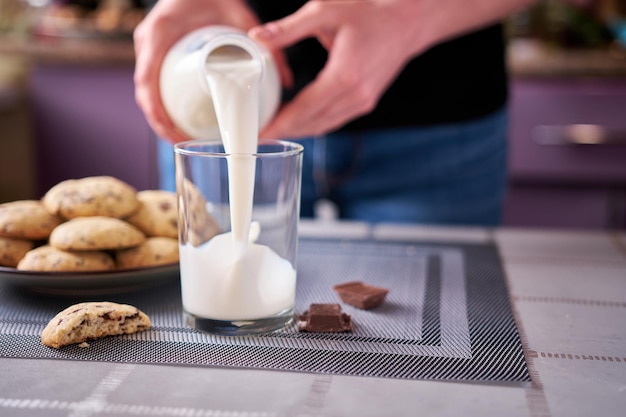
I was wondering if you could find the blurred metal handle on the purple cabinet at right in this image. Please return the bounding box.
[531,124,626,146]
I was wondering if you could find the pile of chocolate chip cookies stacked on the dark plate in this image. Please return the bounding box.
[0,176,193,272]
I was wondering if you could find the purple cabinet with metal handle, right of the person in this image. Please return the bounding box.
[504,78,626,229]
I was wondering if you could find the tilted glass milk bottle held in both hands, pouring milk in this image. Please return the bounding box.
[160,26,281,139]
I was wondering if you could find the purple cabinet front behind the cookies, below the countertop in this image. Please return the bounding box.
[30,65,156,195]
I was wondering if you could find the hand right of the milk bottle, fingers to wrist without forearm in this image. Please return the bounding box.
[249,0,423,138]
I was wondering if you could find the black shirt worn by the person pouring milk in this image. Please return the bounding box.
[248,0,508,130]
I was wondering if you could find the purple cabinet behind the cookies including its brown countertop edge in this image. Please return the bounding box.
[0,36,157,197]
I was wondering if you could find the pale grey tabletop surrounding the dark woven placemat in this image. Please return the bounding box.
[0,221,626,417]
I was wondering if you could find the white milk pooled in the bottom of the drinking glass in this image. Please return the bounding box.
[180,233,296,320]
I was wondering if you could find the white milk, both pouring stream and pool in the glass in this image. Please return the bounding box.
[180,49,296,320]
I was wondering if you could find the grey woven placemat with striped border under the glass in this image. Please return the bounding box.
[0,239,530,382]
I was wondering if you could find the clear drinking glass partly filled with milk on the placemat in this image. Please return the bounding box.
[174,140,303,335]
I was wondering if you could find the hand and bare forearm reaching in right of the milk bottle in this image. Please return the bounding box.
[248,0,537,138]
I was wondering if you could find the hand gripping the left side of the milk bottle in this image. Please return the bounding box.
[134,0,259,142]
